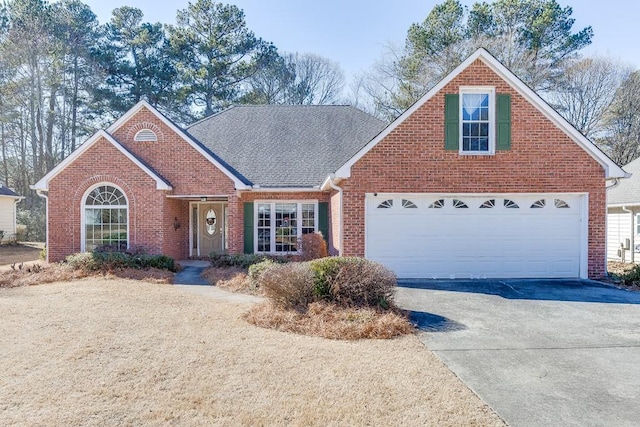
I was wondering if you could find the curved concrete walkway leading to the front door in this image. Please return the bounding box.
[173,260,264,304]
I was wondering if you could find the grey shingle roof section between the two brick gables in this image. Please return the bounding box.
[187,105,385,187]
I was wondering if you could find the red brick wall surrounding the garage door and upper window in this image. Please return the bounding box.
[341,60,606,278]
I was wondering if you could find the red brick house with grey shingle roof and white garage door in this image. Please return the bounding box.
[33,49,626,278]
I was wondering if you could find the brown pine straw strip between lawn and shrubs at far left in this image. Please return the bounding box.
[0,264,174,288]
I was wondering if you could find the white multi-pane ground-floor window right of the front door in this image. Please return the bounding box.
[256,202,318,253]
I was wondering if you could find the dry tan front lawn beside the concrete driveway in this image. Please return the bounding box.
[0,278,504,426]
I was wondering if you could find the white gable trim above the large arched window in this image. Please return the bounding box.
[31,130,172,191]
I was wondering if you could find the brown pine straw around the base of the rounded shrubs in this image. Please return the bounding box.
[243,301,415,340]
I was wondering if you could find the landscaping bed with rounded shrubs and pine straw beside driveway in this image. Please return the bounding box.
[203,235,415,340]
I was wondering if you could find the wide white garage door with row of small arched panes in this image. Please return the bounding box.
[365,194,587,278]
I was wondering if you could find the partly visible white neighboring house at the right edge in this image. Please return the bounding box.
[607,159,640,262]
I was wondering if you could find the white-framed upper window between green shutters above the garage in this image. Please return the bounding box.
[460,88,495,154]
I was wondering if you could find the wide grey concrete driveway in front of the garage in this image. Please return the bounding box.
[397,280,640,426]
